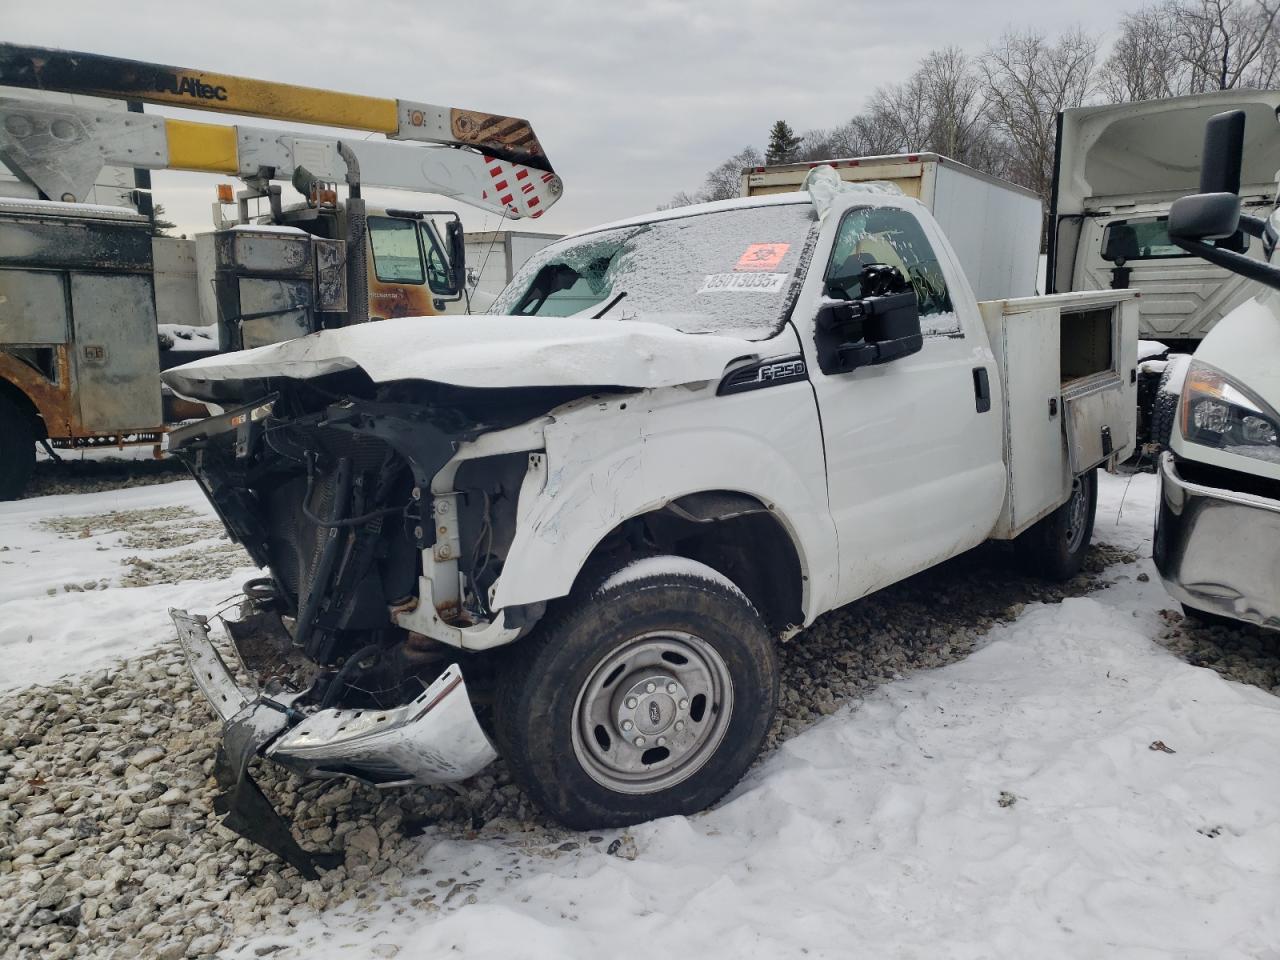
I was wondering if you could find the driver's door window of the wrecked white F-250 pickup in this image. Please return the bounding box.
[827,207,960,337]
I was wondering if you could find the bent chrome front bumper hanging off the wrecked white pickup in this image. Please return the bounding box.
[169,611,497,787]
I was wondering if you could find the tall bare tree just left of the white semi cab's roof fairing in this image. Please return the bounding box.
[979,29,1098,197]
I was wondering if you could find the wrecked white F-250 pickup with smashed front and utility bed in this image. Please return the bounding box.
[165,170,1137,870]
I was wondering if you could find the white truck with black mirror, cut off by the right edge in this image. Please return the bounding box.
[1155,111,1280,630]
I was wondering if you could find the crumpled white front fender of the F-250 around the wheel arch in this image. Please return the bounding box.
[492,381,837,623]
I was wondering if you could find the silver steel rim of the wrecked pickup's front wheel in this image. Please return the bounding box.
[572,631,733,794]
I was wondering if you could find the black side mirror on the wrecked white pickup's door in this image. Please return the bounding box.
[817,289,924,374]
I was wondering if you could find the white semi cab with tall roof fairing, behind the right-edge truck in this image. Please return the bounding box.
[1044,90,1280,353]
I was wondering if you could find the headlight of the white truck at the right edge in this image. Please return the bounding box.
[1180,360,1280,463]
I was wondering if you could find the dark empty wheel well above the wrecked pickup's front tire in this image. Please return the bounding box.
[579,490,804,635]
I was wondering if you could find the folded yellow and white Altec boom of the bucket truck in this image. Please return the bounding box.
[0,44,562,219]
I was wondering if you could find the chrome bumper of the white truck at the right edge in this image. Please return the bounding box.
[1153,452,1280,630]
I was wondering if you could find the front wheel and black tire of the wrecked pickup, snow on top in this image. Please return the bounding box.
[494,557,778,829]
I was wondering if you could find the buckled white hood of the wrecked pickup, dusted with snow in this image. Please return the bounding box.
[161,316,760,401]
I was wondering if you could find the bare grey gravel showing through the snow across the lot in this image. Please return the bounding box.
[0,483,1280,957]
